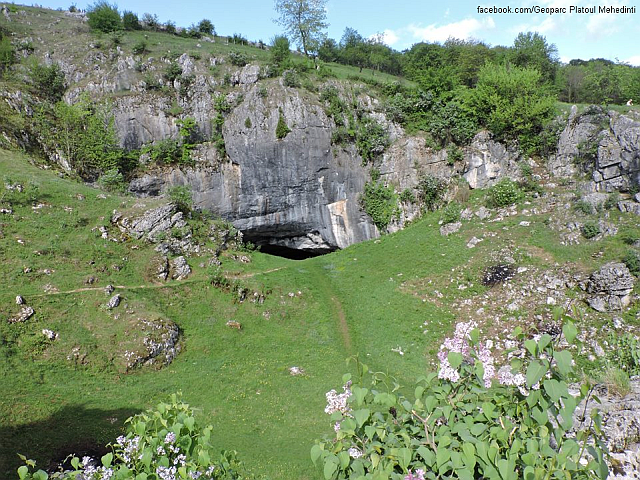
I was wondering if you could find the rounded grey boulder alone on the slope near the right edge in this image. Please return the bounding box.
[587,262,634,312]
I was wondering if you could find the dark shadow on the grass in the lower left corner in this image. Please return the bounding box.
[0,406,143,480]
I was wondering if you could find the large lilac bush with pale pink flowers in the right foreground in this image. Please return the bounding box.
[311,321,608,480]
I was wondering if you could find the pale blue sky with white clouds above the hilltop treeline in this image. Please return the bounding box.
[16,0,640,65]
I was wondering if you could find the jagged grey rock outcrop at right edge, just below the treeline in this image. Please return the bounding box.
[548,106,640,192]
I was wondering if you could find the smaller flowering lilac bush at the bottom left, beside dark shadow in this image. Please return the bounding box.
[18,394,241,480]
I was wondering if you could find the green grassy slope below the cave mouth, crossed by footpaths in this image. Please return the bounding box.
[0,151,460,478]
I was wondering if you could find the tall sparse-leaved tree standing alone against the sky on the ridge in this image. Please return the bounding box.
[275,0,329,56]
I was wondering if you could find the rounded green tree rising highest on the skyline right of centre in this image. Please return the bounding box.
[511,32,558,83]
